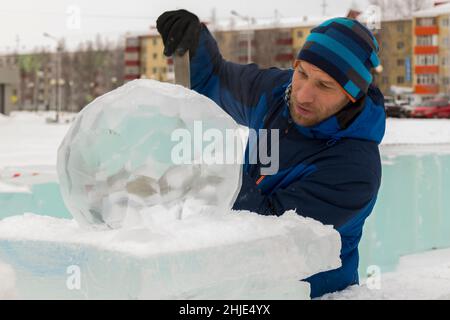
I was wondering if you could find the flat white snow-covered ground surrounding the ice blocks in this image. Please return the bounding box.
[0,112,450,299]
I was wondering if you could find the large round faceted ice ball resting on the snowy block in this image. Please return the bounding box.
[57,80,243,228]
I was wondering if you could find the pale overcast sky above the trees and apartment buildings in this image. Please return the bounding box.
[0,0,367,53]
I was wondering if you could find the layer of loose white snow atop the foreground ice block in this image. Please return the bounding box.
[0,208,340,260]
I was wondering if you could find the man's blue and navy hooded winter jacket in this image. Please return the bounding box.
[191,26,386,298]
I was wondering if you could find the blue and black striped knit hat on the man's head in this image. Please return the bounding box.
[297,18,380,102]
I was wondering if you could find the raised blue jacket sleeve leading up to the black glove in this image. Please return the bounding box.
[191,25,292,127]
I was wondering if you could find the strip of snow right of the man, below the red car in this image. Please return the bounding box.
[382,118,450,145]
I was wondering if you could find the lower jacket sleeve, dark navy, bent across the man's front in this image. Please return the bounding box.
[234,164,381,229]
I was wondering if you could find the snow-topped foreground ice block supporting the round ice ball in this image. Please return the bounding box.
[0,211,340,299]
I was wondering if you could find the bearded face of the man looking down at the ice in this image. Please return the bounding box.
[289,60,350,127]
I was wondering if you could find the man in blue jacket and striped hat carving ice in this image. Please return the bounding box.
[157,10,385,298]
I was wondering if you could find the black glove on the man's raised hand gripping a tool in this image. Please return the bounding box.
[156,9,202,57]
